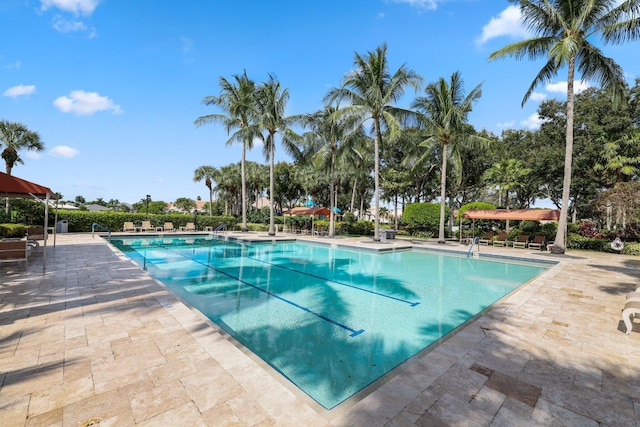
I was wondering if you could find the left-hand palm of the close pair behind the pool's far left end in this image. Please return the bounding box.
[195,71,256,231]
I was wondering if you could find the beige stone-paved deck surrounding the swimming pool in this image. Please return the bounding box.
[0,233,640,427]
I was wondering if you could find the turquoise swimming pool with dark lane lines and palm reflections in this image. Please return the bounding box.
[111,236,548,409]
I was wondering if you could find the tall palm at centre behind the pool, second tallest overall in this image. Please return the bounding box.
[325,44,422,241]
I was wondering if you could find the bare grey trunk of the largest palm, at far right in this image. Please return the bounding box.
[550,56,576,254]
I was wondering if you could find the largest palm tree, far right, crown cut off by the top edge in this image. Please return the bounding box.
[489,0,640,254]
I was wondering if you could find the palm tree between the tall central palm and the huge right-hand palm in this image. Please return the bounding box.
[412,71,488,243]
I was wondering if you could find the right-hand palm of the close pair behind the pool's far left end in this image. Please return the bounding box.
[255,74,304,236]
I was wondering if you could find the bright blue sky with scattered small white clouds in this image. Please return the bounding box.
[0,0,640,203]
